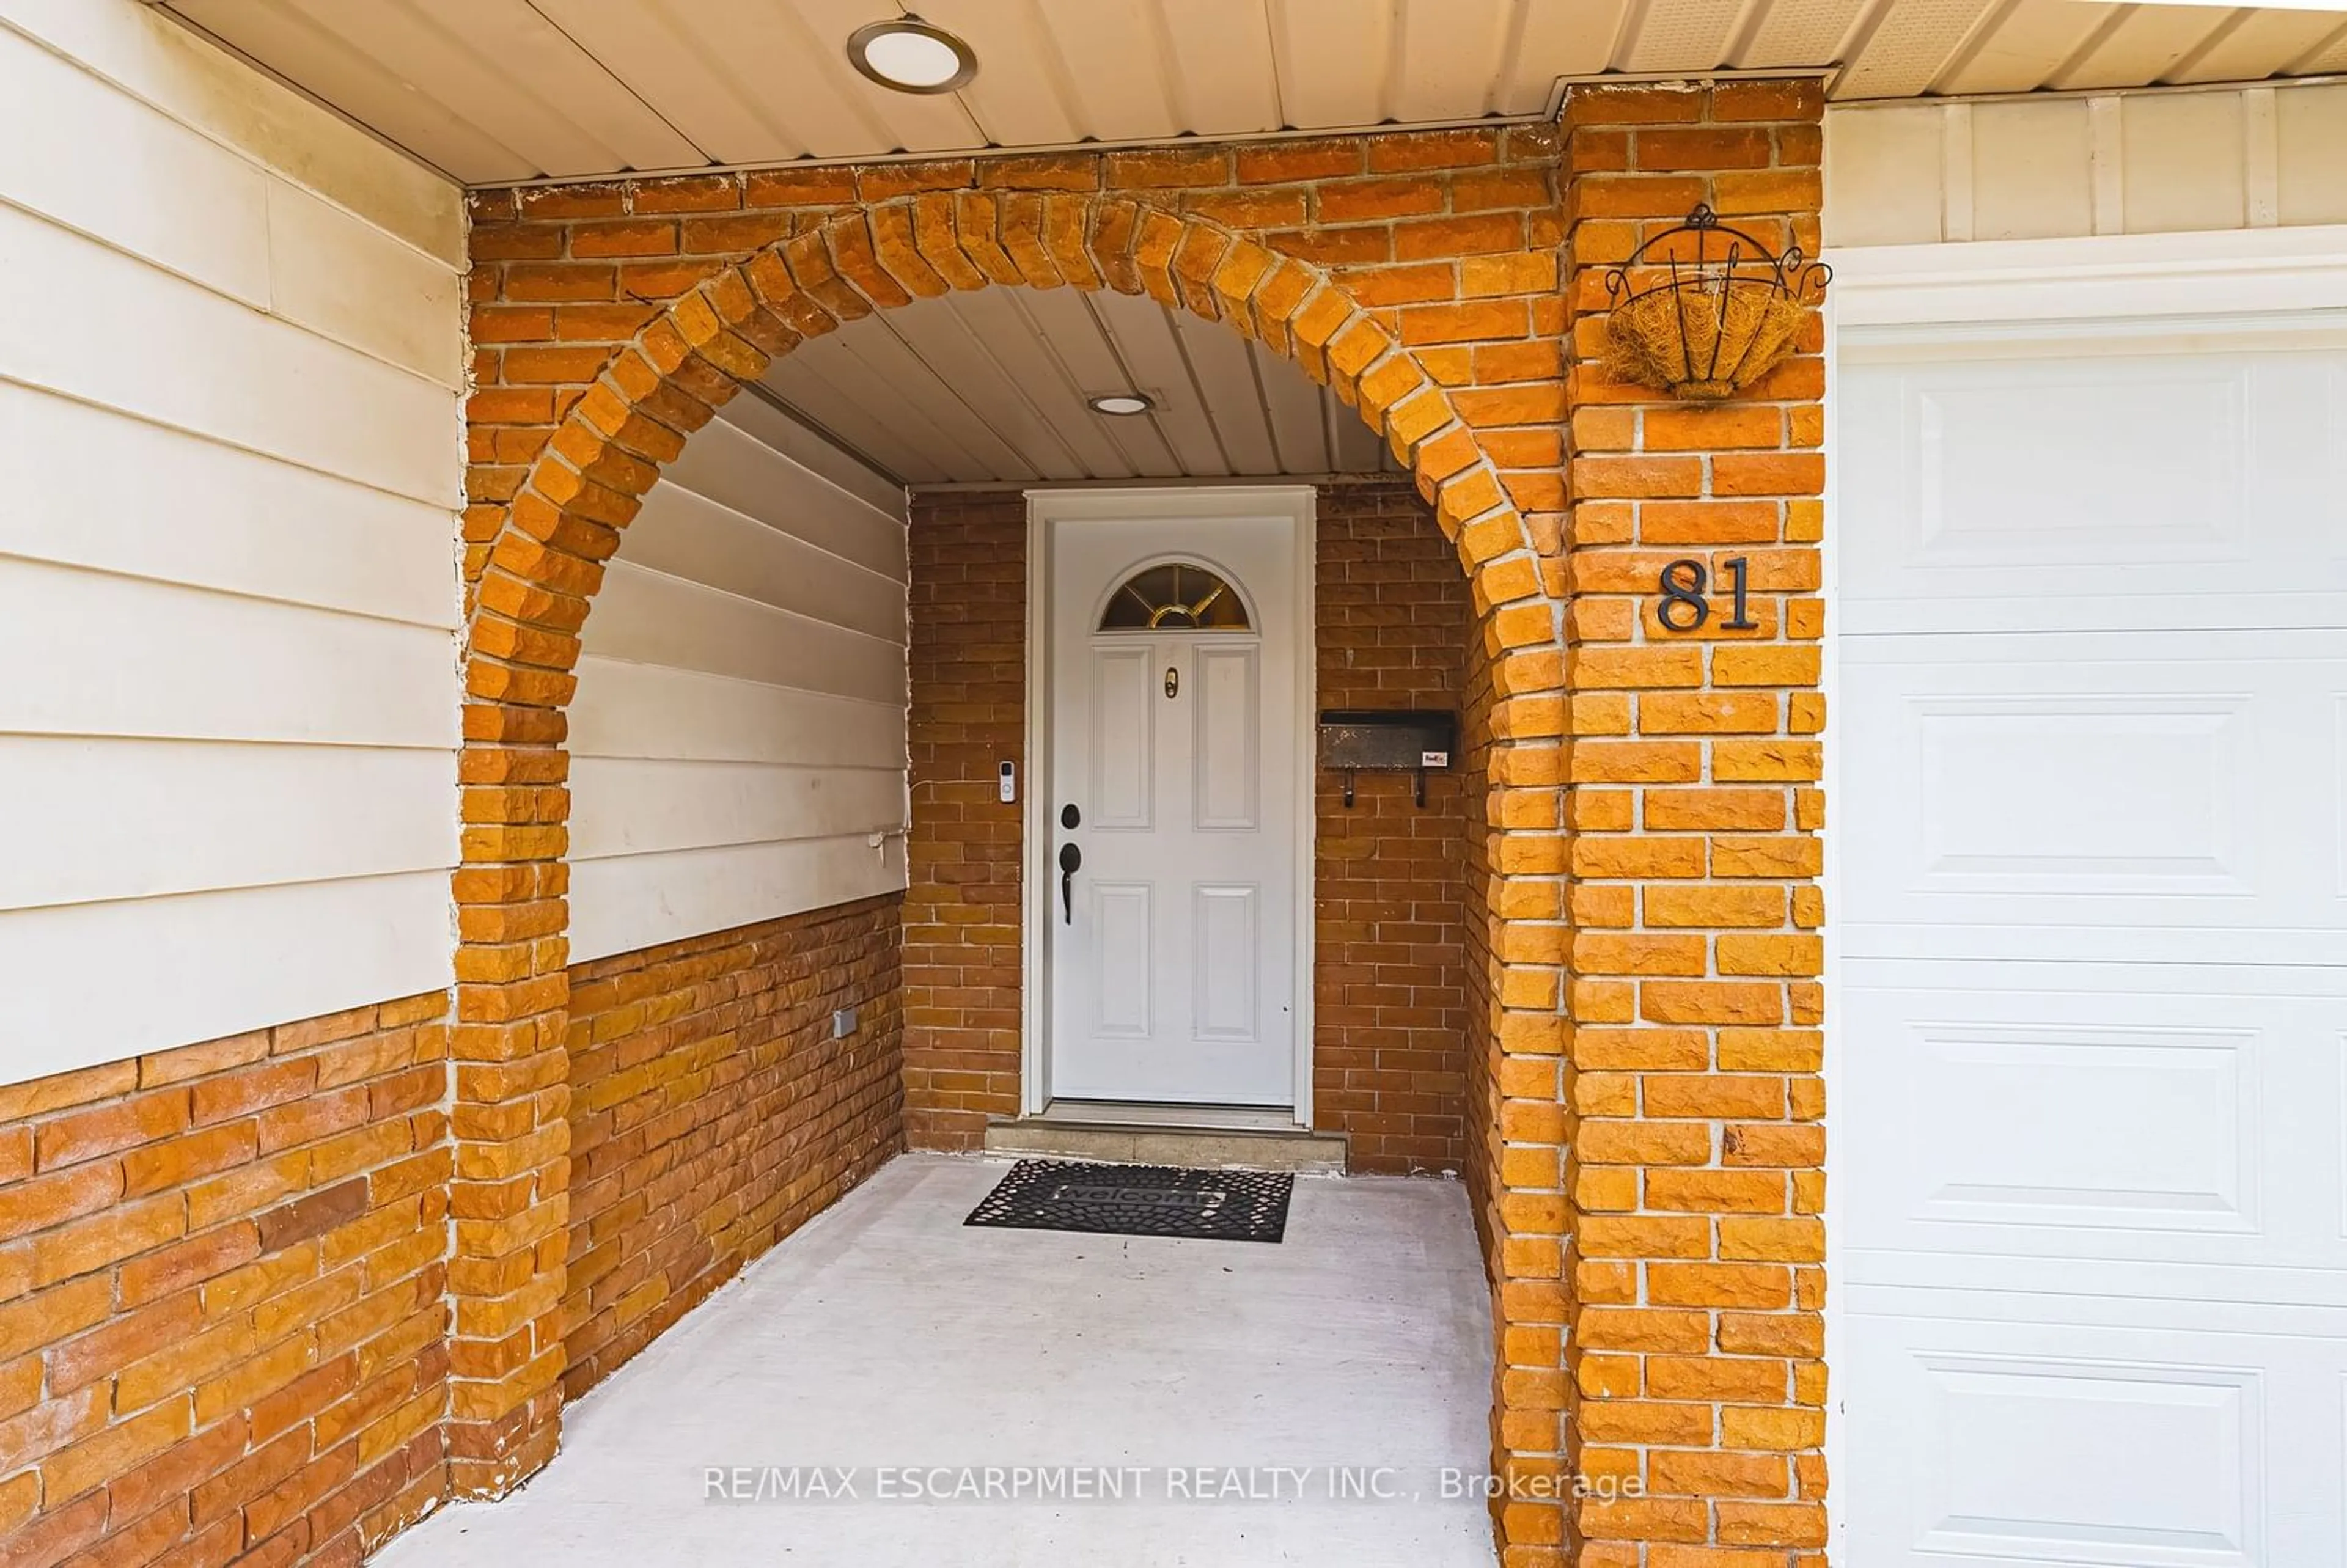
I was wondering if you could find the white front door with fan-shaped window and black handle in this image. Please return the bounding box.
[1030,495,1302,1105]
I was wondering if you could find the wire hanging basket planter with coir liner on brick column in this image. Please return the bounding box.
[1606,204,1833,404]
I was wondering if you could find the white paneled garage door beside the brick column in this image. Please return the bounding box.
[1833,317,2347,1568]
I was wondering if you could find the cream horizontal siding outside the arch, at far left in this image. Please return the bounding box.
[0,0,462,1080]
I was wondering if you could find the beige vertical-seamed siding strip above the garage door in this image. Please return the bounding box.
[1826,82,2347,246]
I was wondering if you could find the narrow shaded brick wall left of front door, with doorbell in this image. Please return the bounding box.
[903,493,1026,1148]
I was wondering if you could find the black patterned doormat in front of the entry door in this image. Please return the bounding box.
[962,1160,1296,1242]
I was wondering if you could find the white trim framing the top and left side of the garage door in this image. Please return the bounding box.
[1819,225,2347,1561]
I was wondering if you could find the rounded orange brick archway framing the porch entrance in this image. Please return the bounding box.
[450,190,1563,1495]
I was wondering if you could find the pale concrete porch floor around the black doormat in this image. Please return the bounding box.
[373,1155,1495,1568]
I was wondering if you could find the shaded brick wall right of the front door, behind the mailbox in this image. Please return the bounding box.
[1312,481,1481,1171]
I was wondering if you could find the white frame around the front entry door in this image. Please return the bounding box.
[1019,483,1319,1127]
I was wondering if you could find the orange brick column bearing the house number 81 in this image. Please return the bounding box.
[1565,82,1826,1568]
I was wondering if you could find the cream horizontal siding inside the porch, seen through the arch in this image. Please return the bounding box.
[570,397,906,960]
